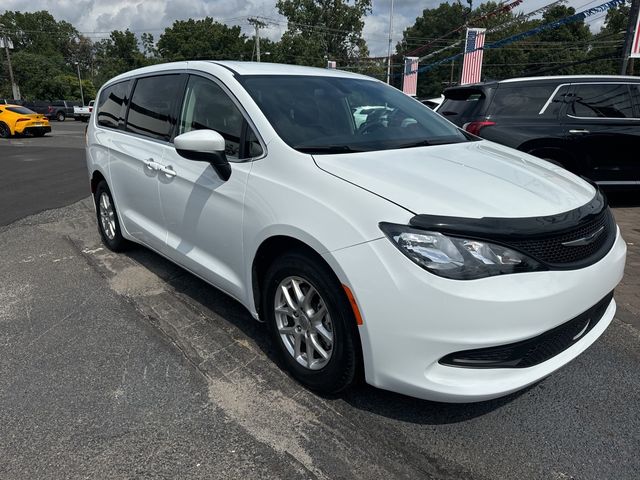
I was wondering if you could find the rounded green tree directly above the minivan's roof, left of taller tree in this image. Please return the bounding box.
[158,17,250,61]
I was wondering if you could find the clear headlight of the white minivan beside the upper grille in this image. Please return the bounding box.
[380,222,545,280]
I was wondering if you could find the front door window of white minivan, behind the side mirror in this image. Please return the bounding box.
[178,76,243,159]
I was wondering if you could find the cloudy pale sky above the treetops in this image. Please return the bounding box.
[2,0,606,56]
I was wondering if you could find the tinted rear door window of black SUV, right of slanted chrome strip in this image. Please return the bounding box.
[569,84,633,118]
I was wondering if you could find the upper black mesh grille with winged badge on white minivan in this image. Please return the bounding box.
[508,208,616,267]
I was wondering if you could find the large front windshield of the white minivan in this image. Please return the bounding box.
[240,75,475,154]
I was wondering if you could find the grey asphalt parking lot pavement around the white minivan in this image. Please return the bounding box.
[0,121,640,480]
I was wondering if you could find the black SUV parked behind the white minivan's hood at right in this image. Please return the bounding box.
[438,76,640,186]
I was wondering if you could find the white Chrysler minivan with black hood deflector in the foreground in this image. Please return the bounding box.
[87,61,626,402]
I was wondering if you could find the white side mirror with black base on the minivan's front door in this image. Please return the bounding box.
[173,130,231,182]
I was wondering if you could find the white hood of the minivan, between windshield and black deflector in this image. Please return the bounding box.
[314,140,595,218]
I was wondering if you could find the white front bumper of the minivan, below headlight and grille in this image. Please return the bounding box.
[326,230,626,402]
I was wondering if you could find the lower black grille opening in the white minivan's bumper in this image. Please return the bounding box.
[440,292,613,368]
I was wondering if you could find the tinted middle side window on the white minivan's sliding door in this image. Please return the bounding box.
[126,75,182,142]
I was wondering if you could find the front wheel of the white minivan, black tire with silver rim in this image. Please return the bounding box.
[261,252,359,394]
